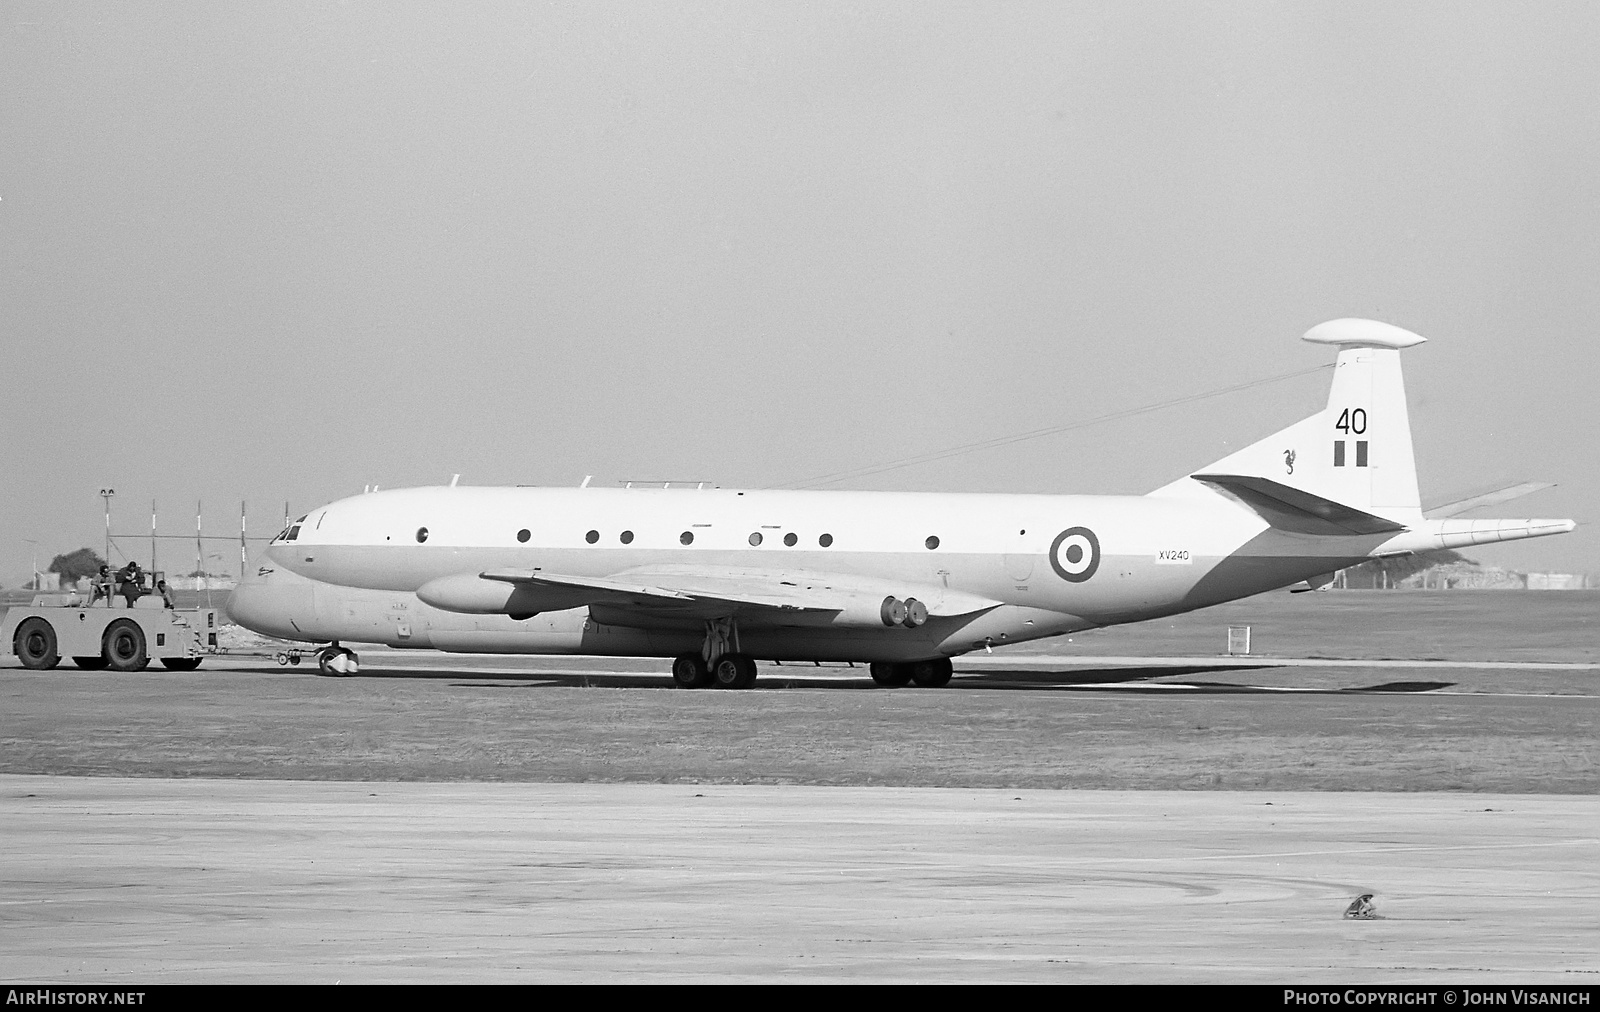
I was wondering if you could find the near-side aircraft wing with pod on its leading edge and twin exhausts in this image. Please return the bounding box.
[480,565,1000,624]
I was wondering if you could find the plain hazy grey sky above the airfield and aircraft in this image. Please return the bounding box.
[0,0,1600,586]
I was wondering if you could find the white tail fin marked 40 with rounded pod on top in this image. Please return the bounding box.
[1152,320,1426,527]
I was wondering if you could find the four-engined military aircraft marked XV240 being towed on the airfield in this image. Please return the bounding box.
[229,320,1574,689]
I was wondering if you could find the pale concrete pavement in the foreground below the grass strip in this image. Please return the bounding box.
[0,777,1600,986]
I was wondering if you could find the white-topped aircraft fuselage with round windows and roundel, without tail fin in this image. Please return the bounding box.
[229,487,1384,660]
